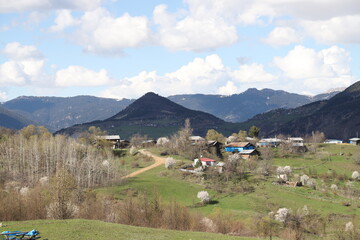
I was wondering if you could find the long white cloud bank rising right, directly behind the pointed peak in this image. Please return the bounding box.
[101,54,275,98]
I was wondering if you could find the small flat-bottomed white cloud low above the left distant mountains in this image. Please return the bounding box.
[55,66,111,87]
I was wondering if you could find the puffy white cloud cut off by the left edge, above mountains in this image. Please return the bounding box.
[0,42,45,85]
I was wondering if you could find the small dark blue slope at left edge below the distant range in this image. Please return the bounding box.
[0,106,36,129]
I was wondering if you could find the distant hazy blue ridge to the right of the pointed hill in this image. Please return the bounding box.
[168,88,338,122]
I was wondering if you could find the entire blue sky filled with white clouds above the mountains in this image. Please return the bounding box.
[0,0,360,102]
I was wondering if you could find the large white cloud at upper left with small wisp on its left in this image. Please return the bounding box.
[50,8,151,55]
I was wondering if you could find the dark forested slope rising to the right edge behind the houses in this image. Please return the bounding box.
[241,82,360,140]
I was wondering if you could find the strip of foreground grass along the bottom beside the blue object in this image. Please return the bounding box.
[0,219,257,240]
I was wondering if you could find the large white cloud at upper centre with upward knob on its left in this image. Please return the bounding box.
[154,5,238,51]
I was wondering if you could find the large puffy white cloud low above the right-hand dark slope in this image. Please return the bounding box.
[273,45,355,93]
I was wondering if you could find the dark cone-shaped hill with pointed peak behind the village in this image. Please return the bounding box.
[58,93,237,138]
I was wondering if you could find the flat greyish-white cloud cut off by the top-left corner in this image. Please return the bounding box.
[0,0,102,13]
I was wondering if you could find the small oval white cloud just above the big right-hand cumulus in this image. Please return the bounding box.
[264,27,301,46]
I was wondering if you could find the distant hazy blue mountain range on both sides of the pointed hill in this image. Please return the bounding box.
[0,88,337,131]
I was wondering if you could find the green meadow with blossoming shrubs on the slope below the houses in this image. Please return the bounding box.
[96,145,360,219]
